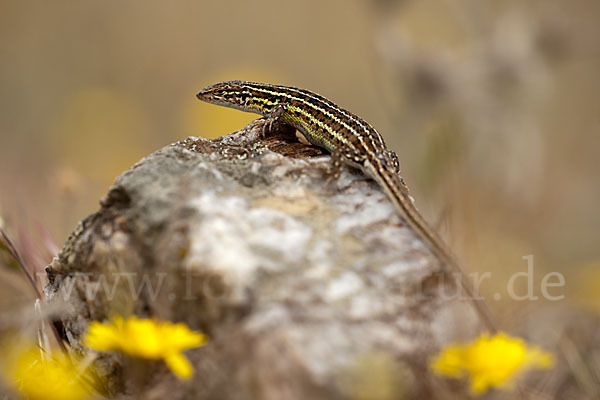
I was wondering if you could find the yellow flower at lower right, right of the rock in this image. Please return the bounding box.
[431,333,554,394]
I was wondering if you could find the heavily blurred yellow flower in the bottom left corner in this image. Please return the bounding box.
[11,347,92,400]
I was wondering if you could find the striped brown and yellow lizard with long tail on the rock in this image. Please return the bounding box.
[196,80,496,332]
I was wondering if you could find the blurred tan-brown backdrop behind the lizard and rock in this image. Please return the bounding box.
[0,0,600,394]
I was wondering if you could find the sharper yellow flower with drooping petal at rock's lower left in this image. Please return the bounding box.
[84,316,206,379]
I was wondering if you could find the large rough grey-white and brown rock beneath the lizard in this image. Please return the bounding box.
[46,121,479,400]
